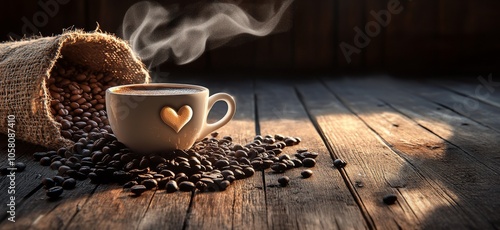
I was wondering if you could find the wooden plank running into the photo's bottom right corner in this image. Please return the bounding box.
[328,78,500,228]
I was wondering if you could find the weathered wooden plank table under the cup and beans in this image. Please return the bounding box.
[0,77,500,229]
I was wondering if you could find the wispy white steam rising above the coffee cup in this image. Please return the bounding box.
[121,0,293,68]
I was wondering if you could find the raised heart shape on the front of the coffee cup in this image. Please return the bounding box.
[160,105,193,133]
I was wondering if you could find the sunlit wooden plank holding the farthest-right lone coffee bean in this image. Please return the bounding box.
[297,82,476,229]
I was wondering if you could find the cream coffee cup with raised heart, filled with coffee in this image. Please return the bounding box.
[106,83,236,153]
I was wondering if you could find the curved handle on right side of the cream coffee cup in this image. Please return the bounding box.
[198,93,236,140]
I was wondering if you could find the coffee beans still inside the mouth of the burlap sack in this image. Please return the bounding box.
[47,58,118,141]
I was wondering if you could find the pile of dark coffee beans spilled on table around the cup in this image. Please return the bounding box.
[34,131,318,197]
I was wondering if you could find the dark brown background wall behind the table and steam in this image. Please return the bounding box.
[0,0,500,77]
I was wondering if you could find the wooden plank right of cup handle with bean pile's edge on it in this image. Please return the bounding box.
[256,81,369,229]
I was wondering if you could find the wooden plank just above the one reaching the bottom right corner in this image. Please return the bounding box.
[343,79,500,173]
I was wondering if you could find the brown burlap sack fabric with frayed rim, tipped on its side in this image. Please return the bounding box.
[0,31,150,149]
